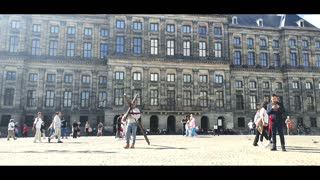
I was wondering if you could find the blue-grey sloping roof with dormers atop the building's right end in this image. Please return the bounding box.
[229,14,317,28]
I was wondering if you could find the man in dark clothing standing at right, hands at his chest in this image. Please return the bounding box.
[267,94,287,151]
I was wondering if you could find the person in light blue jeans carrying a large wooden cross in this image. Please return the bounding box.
[123,103,141,149]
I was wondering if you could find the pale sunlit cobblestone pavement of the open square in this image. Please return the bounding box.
[0,135,320,166]
